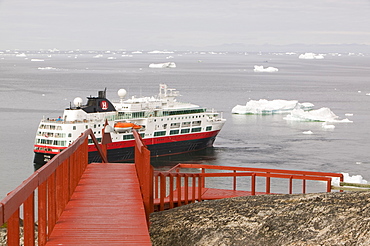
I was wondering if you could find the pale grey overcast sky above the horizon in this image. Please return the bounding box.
[0,0,370,50]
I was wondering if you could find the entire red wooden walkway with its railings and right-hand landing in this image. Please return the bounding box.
[0,129,343,246]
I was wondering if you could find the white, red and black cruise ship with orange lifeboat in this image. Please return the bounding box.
[34,84,226,166]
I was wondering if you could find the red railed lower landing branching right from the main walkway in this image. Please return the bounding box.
[154,164,343,211]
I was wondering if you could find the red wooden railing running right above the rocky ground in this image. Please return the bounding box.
[154,164,343,211]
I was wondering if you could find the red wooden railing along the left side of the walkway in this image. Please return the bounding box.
[0,129,107,246]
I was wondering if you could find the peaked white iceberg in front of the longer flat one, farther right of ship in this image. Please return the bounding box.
[284,107,352,123]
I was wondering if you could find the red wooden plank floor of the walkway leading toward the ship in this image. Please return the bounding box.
[46,163,151,246]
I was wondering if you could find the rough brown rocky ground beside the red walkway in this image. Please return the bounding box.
[150,192,370,246]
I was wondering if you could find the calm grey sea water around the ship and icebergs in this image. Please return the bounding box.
[0,51,370,199]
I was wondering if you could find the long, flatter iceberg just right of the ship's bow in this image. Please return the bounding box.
[231,99,314,114]
